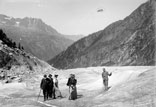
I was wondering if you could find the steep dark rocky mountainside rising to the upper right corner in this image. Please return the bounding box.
[48,0,156,69]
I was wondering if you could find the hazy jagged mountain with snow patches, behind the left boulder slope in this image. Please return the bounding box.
[0,14,73,60]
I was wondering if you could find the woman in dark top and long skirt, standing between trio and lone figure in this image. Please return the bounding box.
[67,74,77,100]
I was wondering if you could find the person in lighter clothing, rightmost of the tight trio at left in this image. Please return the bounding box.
[54,75,62,98]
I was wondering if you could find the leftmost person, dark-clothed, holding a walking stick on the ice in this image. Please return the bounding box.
[40,75,48,101]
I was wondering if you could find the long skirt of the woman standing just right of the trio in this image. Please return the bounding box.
[69,86,77,100]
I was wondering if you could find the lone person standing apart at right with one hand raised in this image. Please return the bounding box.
[102,68,112,90]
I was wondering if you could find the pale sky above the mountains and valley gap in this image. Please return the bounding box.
[0,0,147,35]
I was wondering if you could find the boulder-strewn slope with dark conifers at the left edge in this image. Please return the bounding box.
[0,30,54,79]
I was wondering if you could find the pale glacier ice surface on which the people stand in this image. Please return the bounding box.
[0,66,156,107]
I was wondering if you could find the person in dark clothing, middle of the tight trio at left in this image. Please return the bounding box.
[48,74,55,99]
